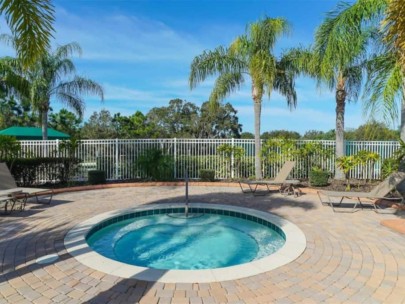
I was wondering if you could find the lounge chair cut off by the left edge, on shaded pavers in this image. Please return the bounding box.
[0,163,53,205]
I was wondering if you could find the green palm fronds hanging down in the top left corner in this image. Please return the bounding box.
[0,0,54,68]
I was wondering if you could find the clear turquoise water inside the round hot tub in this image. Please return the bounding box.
[87,214,285,269]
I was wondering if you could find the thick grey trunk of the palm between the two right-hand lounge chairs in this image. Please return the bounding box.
[335,77,346,180]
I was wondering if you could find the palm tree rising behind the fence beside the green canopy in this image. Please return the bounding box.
[27,43,104,140]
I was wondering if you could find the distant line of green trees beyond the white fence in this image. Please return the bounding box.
[0,95,399,140]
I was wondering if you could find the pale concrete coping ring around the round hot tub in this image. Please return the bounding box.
[64,203,306,283]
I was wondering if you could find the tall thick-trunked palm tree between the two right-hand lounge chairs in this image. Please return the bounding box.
[287,0,378,180]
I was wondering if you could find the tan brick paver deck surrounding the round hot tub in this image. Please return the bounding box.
[0,186,405,304]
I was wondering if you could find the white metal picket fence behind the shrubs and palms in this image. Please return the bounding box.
[17,138,399,180]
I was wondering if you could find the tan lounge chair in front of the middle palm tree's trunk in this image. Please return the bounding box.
[239,161,301,196]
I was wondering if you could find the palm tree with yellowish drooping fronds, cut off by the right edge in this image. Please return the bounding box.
[334,0,405,140]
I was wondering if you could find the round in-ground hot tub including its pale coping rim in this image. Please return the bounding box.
[65,203,306,283]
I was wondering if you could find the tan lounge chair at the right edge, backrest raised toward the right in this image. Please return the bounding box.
[318,172,405,212]
